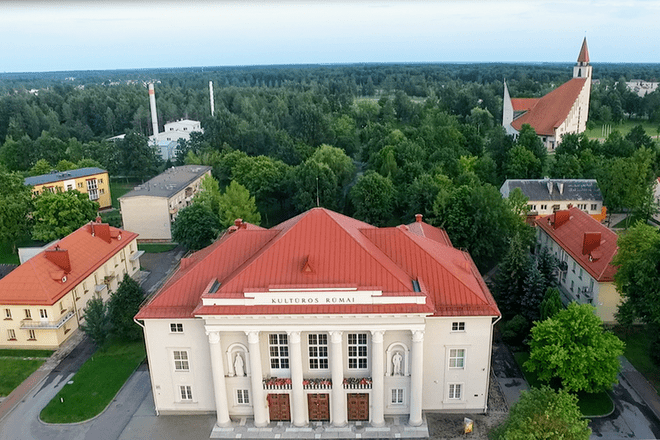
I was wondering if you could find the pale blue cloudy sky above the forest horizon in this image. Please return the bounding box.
[0,0,660,72]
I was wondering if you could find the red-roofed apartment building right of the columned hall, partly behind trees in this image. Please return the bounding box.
[535,208,621,323]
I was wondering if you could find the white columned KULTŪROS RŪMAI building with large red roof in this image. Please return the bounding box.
[136,208,500,438]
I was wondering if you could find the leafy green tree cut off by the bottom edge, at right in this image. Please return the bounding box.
[490,386,591,440]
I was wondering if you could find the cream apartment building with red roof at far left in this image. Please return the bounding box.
[0,219,141,349]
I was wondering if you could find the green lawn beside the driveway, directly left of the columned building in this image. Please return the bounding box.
[41,341,145,423]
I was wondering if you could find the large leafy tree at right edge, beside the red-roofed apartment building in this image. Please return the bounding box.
[612,221,660,328]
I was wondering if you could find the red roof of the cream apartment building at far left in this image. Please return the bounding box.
[0,223,138,306]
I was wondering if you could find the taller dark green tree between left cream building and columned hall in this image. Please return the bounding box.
[108,274,144,341]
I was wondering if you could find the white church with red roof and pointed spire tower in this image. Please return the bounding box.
[502,37,592,151]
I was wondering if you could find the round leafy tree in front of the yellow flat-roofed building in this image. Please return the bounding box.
[32,190,99,242]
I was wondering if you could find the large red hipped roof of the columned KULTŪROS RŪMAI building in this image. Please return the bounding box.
[136,208,500,319]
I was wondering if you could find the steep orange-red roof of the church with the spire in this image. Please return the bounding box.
[511,78,587,136]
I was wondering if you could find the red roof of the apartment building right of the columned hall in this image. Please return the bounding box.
[534,208,618,282]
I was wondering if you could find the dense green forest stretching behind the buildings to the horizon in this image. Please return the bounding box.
[0,64,660,267]
